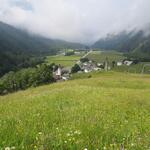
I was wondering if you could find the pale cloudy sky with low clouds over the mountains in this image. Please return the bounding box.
[0,0,150,44]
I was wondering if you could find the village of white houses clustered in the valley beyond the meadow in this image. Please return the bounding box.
[53,50,134,81]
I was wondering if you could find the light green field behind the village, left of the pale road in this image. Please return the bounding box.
[46,55,82,67]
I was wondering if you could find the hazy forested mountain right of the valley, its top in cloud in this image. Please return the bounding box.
[92,30,150,59]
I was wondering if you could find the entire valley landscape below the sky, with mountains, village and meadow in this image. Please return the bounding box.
[0,22,150,150]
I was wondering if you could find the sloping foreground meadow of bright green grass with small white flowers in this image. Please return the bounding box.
[0,72,150,150]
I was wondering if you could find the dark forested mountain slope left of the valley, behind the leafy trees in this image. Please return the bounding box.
[0,22,84,76]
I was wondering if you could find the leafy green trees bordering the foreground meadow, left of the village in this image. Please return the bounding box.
[0,64,55,95]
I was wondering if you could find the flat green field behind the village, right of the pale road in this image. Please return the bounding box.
[87,51,126,63]
